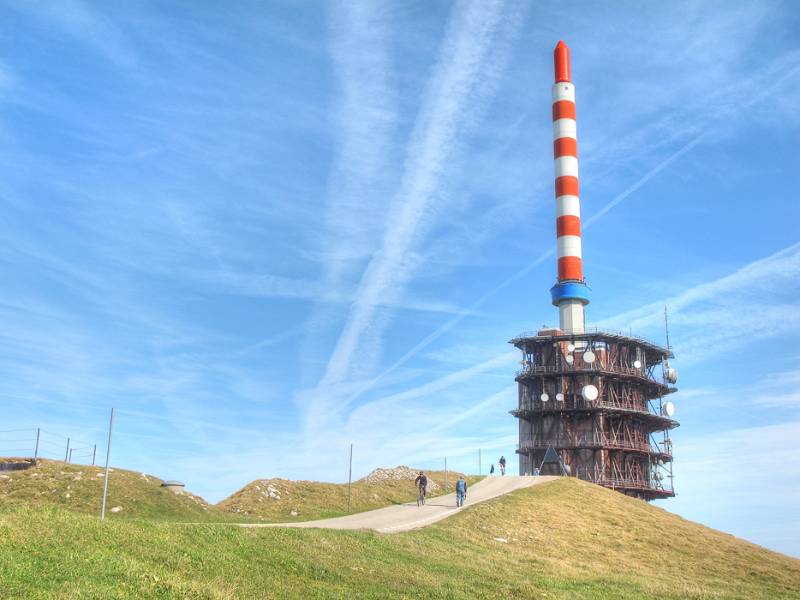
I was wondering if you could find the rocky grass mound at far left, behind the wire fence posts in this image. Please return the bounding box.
[0,460,236,521]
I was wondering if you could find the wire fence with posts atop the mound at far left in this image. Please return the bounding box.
[0,427,97,465]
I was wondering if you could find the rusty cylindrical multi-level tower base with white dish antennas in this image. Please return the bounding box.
[511,329,678,500]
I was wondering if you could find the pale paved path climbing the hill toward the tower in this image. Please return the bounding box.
[241,475,558,533]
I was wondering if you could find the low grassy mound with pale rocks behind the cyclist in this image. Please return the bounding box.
[217,466,479,522]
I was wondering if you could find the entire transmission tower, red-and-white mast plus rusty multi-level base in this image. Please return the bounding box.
[511,41,678,500]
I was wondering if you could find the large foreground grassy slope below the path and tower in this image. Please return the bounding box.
[0,479,800,600]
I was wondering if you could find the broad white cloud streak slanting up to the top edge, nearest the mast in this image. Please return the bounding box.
[311,2,532,436]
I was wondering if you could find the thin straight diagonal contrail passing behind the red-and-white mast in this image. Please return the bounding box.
[344,133,705,406]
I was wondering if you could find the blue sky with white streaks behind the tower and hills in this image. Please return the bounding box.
[0,0,800,556]
